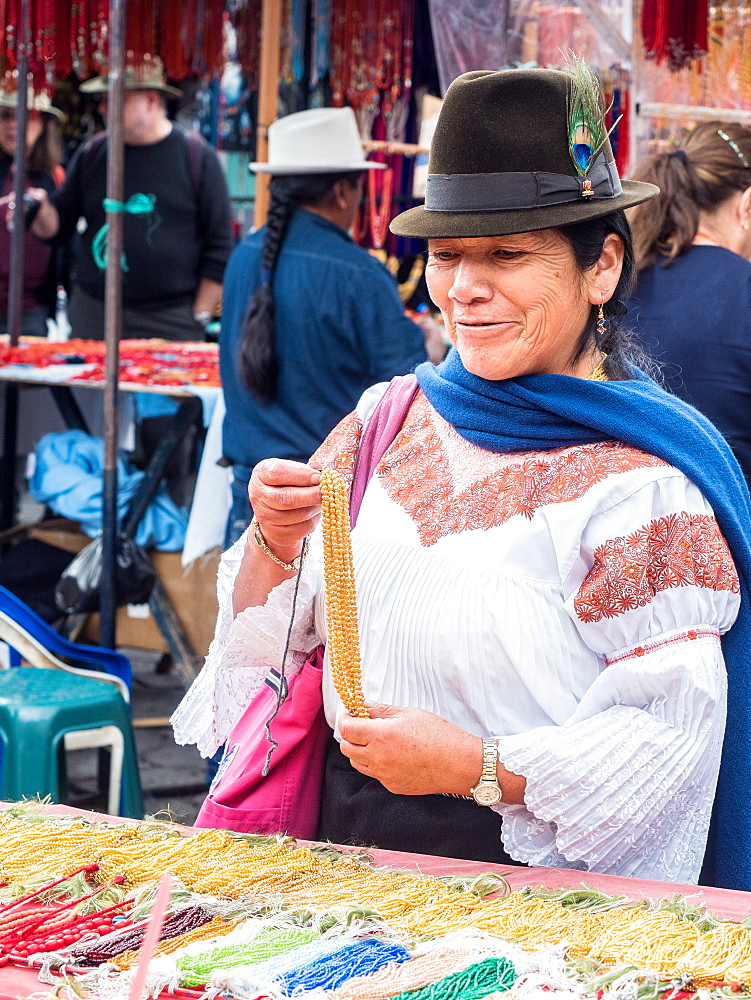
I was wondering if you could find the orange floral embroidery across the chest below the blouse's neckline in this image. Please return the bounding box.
[377,393,667,546]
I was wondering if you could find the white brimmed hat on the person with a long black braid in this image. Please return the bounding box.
[250,108,385,174]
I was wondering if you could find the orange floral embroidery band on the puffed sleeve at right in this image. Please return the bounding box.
[574,511,740,622]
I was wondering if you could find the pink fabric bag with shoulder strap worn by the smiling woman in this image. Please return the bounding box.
[194,375,417,840]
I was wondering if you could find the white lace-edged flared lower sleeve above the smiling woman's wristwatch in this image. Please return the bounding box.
[497,637,725,882]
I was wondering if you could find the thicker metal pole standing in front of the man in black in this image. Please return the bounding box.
[99,0,126,649]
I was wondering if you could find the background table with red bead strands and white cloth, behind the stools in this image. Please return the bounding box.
[0,338,230,683]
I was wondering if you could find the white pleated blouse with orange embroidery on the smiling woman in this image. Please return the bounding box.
[173,385,739,882]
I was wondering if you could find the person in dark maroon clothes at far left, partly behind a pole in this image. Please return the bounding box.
[0,91,64,337]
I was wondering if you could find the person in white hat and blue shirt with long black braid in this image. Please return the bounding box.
[219,108,438,544]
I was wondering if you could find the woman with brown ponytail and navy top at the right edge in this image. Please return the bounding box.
[626,121,751,483]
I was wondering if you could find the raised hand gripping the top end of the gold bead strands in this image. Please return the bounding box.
[248,458,321,562]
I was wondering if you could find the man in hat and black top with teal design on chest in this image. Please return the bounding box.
[30,58,232,340]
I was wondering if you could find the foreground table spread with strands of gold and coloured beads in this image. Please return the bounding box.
[0,806,751,1000]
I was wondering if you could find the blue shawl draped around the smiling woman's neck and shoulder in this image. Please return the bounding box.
[417,351,751,890]
